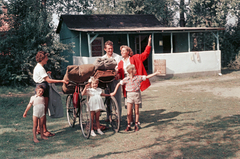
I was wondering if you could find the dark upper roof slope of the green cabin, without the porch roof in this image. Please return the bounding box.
[57,14,160,32]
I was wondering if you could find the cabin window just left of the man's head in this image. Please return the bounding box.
[91,37,104,57]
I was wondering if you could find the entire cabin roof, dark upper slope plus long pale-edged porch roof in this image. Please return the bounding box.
[56,14,224,33]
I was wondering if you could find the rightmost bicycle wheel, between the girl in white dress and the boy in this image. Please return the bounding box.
[105,97,121,132]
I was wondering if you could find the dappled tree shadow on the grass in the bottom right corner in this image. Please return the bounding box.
[153,115,240,158]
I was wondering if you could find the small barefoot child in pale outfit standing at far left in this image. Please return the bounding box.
[23,85,48,143]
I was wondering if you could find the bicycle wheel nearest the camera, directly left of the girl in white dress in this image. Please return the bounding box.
[79,99,92,139]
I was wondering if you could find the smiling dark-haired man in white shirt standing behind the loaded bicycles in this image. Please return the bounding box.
[102,40,122,118]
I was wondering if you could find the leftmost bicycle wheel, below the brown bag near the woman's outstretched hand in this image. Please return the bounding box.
[66,95,76,127]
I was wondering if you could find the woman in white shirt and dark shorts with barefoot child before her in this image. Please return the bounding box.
[23,51,69,143]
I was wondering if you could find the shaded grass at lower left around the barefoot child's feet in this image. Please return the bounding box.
[0,97,124,158]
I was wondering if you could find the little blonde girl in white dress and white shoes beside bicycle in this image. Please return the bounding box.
[82,77,110,136]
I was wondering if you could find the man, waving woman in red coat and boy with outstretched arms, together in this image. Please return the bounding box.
[100,35,160,131]
